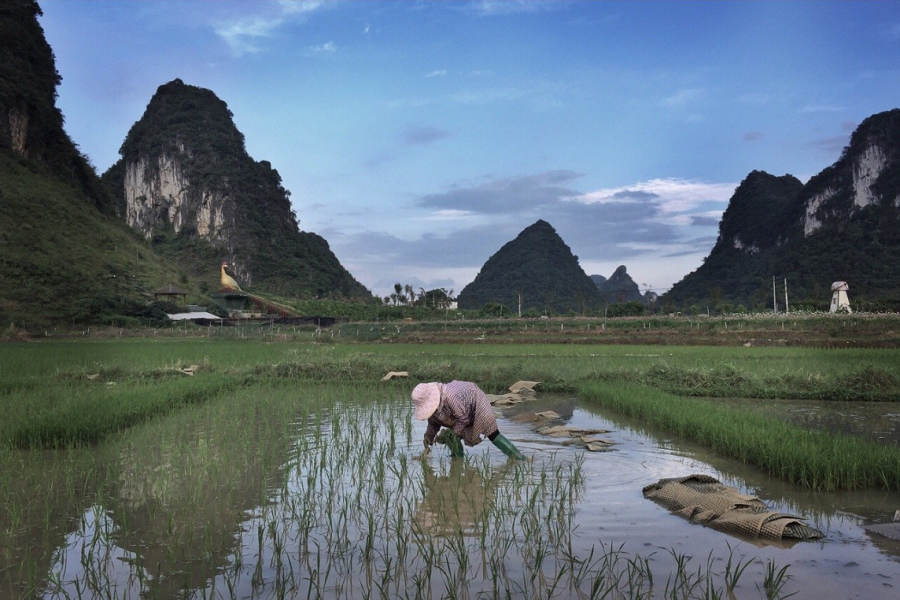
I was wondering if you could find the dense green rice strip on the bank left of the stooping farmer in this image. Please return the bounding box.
[6,377,237,449]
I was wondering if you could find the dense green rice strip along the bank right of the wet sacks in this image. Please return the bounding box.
[579,382,900,491]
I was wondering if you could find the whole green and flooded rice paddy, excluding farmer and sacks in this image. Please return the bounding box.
[0,335,900,599]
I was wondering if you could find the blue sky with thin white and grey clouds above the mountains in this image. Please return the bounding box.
[40,0,900,296]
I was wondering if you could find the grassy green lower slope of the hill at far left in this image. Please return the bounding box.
[0,152,199,330]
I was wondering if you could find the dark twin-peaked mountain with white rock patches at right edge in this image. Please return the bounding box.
[661,109,900,308]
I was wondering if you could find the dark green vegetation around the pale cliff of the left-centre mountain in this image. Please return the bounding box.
[103,79,372,302]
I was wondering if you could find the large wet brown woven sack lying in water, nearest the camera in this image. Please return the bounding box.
[643,475,825,541]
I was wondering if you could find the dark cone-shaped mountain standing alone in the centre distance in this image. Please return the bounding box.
[457,220,601,314]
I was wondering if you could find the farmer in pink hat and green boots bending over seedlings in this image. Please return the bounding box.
[412,381,525,459]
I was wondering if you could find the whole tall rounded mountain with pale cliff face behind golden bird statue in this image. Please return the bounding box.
[103,79,373,301]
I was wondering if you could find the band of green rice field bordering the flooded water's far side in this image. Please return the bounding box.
[0,339,900,489]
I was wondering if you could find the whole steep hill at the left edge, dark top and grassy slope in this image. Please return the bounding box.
[0,0,204,330]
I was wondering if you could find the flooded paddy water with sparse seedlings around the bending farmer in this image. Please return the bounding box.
[0,384,900,599]
